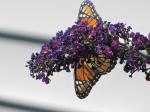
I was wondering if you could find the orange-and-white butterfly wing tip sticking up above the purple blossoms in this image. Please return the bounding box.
[78,0,102,27]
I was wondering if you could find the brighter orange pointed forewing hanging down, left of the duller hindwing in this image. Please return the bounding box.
[75,58,101,99]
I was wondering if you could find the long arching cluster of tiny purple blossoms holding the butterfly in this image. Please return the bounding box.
[27,21,150,84]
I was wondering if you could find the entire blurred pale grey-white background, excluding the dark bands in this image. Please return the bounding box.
[0,0,150,112]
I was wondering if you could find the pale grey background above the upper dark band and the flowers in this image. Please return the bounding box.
[0,0,150,35]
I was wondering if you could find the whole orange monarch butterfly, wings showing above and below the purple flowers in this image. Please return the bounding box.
[74,0,115,99]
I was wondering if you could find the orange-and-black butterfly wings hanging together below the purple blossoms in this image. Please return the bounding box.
[74,55,116,99]
